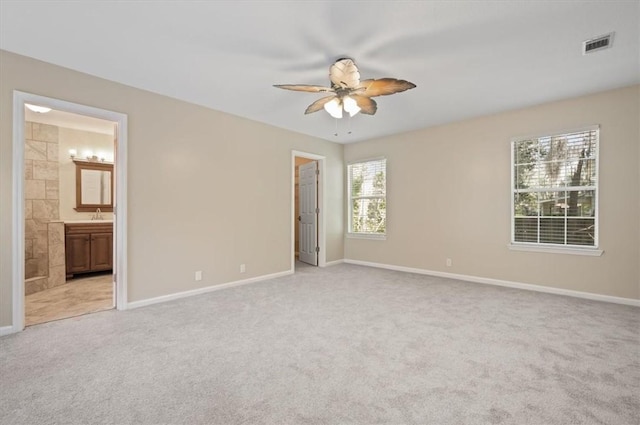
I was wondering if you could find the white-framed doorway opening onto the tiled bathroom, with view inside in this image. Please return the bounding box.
[13,92,126,331]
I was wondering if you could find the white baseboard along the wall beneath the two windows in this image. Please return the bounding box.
[344,259,640,307]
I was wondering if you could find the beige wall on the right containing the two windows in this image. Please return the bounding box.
[345,86,640,299]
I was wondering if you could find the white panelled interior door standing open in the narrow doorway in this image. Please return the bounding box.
[298,161,318,266]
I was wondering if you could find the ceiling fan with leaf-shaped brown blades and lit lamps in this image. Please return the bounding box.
[274,58,416,118]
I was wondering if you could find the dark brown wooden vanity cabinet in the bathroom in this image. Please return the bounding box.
[64,222,113,278]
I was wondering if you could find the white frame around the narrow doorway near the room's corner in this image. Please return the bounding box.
[291,150,327,271]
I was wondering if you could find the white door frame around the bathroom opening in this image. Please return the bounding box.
[11,90,127,333]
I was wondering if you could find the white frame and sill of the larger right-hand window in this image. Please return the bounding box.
[509,125,603,256]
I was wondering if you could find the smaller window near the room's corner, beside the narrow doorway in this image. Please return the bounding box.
[347,158,387,237]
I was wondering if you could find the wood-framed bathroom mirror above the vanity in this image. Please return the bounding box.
[73,160,113,212]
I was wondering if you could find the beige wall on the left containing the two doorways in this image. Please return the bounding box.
[0,51,344,326]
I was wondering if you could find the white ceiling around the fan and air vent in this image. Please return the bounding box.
[0,0,640,143]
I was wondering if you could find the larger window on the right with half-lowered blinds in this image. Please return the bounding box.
[511,127,599,252]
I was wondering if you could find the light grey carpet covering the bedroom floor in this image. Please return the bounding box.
[0,264,640,425]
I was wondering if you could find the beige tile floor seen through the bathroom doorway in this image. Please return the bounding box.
[25,273,113,326]
